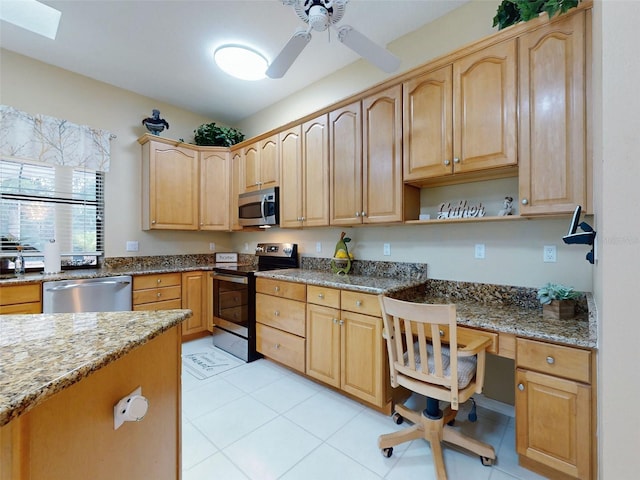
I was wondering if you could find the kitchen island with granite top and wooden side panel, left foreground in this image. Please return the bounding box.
[0,310,191,480]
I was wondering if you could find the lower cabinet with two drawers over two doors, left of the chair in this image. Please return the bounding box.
[306,286,390,407]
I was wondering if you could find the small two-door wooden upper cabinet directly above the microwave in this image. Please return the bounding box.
[243,134,280,192]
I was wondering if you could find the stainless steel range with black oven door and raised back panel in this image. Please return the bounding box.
[211,243,299,362]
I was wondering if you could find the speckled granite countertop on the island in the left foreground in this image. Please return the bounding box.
[0,310,191,426]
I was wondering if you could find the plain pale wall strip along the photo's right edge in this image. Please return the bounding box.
[593,1,640,479]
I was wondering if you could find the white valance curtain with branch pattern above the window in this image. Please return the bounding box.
[0,105,114,172]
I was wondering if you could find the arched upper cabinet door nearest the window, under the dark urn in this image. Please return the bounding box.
[143,141,199,230]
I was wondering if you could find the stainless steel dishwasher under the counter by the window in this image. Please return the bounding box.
[42,275,131,313]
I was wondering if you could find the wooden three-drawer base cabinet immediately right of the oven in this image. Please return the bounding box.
[256,278,306,373]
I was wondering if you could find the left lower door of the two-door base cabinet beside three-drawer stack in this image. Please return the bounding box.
[306,304,341,388]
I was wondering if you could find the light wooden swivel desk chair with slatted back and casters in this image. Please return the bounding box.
[378,295,496,480]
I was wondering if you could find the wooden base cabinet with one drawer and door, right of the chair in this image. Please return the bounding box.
[516,338,594,479]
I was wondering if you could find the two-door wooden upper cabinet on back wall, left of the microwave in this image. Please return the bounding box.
[139,134,230,231]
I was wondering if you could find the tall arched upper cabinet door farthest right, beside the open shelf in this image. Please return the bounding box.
[518,12,587,215]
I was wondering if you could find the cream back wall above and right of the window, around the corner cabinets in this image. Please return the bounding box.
[0,50,235,257]
